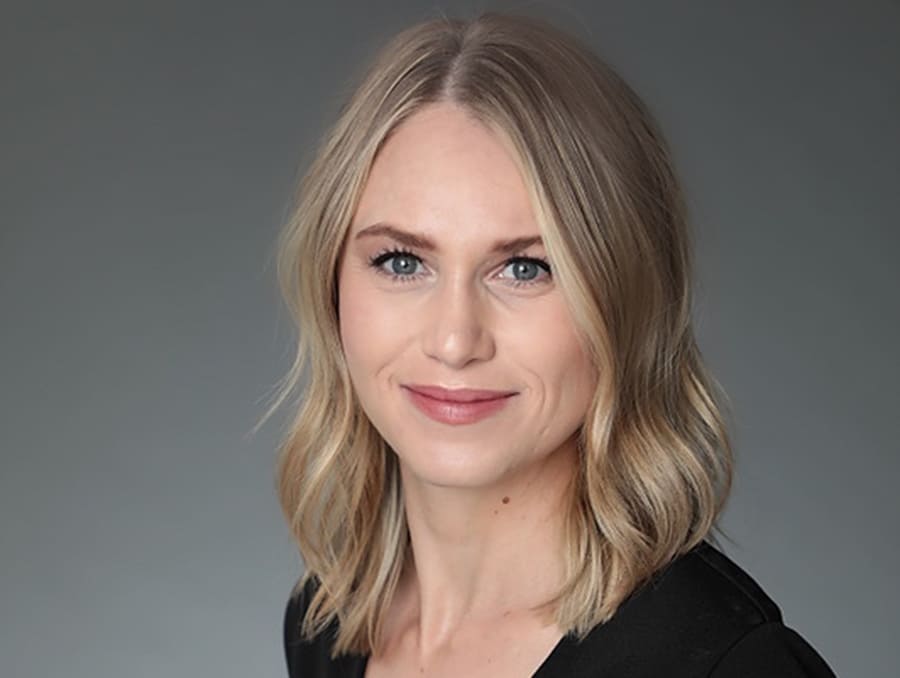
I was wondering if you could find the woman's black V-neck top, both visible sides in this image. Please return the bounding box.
[284,542,834,678]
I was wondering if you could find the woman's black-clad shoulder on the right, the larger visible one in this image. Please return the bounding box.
[560,542,834,678]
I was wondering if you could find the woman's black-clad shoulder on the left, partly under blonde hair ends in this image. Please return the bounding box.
[284,578,363,678]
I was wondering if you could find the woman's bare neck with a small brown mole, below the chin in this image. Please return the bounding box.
[397,444,577,645]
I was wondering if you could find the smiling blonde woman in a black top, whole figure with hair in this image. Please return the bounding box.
[276,14,833,678]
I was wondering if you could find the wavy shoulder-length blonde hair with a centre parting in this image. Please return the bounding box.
[266,9,732,655]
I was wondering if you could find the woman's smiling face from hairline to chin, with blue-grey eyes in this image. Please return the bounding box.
[338,103,596,488]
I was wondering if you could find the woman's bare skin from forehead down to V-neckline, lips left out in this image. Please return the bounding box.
[338,103,596,678]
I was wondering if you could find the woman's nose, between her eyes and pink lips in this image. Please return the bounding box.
[422,277,495,369]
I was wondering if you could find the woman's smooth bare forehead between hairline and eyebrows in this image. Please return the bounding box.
[351,103,537,240]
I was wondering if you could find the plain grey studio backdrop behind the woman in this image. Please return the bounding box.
[0,0,900,678]
